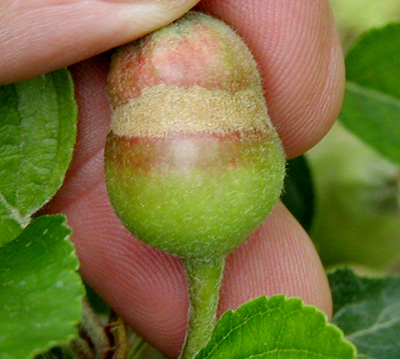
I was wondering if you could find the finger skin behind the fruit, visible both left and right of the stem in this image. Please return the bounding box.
[45,54,331,357]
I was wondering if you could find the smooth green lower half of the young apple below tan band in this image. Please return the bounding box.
[106,134,284,259]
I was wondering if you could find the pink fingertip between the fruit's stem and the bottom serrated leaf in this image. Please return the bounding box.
[220,203,332,317]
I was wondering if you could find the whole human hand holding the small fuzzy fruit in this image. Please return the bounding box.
[0,0,344,356]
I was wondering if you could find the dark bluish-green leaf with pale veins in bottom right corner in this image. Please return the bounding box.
[329,268,400,359]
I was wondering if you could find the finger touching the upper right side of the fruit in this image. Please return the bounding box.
[198,0,344,158]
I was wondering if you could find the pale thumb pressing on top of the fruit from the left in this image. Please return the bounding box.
[0,0,199,84]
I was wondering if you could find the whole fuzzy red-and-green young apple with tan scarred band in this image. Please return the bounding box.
[105,12,285,259]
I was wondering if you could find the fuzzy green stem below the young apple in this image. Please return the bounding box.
[180,257,225,359]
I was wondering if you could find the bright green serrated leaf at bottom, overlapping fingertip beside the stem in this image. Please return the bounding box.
[196,295,355,359]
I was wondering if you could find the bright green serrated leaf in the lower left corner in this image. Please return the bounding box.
[0,215,84,359]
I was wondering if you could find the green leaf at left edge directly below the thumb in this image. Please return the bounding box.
[0,69,77,244]
